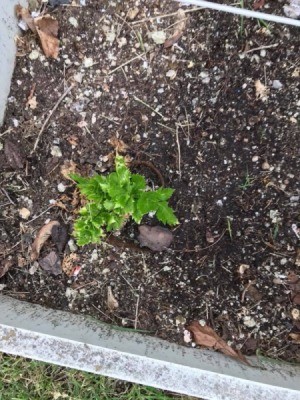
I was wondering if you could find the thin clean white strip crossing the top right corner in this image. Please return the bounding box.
[177,0,300,27]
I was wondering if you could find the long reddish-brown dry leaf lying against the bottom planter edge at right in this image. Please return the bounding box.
[188,321,249,365]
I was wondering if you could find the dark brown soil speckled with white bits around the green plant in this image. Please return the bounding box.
[0,0,300,361]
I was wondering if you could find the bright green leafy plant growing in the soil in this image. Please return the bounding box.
[70,155,178,246]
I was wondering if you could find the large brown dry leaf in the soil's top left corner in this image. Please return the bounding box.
[34,14,59,58]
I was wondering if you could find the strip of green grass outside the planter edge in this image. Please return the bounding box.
[0,353,193,400]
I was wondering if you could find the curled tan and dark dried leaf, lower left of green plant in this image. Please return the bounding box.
[31,221,67,261]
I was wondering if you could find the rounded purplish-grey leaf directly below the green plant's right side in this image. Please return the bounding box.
[138,225,174,251]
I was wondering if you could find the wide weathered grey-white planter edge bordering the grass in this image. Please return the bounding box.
[0,295,300,400]
